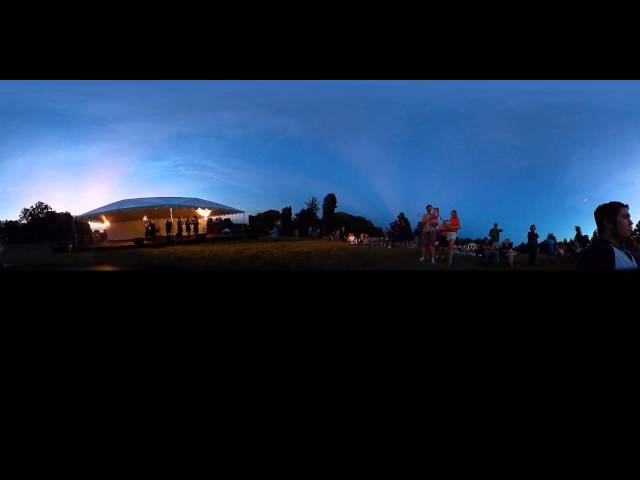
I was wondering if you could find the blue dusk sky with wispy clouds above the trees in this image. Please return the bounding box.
[0,81,640,243]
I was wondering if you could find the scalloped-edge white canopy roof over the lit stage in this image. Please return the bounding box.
[76,197,244,223]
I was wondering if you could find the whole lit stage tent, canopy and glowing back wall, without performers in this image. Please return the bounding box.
[76,197,244,240]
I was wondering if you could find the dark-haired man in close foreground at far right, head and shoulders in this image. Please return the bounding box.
[578,202,639,271]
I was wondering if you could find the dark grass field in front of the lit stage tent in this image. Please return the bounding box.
[1,239,575,271]
